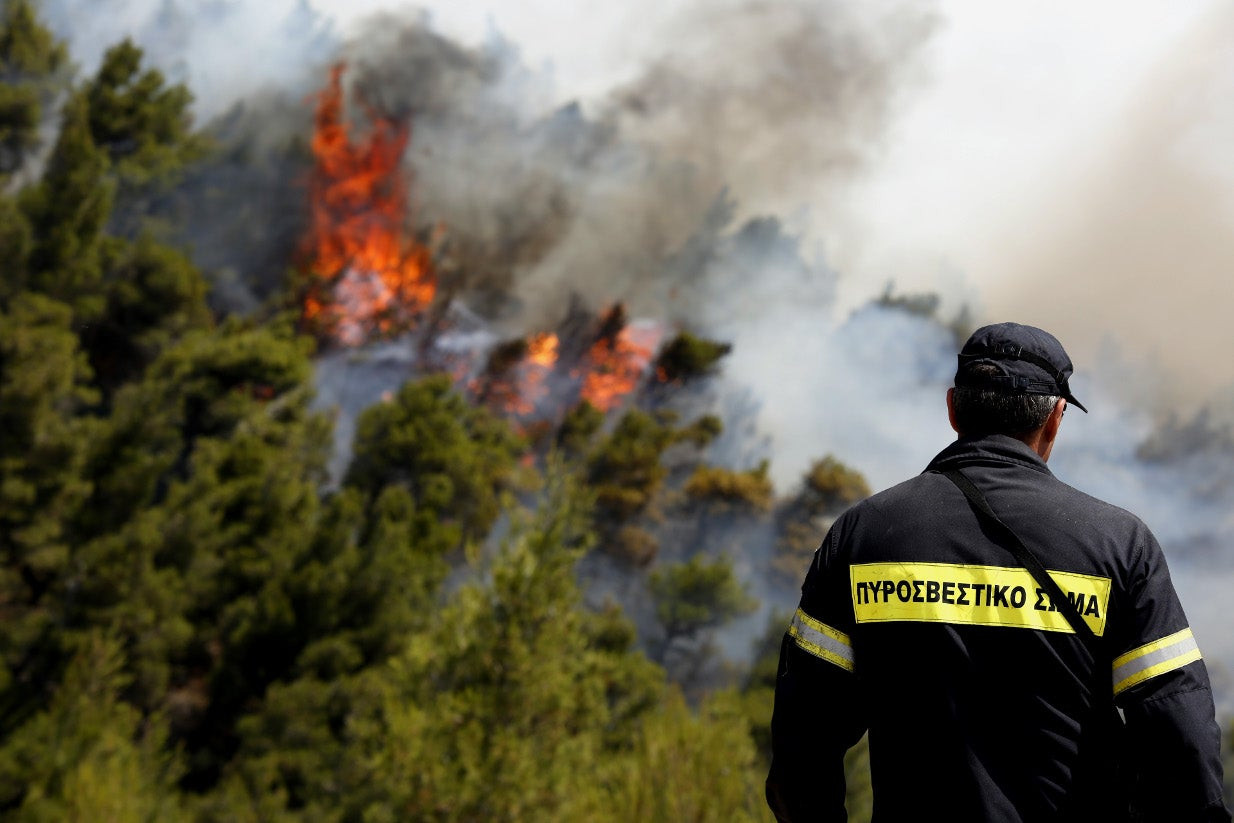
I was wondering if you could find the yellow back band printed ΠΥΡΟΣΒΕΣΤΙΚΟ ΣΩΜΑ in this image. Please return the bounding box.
[849,563,1109,637]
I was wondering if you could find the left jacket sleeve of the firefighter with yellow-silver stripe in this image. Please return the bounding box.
[766,523,866,823]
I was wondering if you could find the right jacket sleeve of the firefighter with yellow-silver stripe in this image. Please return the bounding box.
[1112,533,1230,822]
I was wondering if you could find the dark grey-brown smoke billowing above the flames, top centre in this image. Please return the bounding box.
[328,0,933,333]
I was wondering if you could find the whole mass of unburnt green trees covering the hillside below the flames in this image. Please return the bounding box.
[0,6,799,823]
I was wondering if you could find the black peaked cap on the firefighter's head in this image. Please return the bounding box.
[955,323,1088,412]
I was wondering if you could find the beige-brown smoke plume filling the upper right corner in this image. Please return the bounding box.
[986,4,1234,415]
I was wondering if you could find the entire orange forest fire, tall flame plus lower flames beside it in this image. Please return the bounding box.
[304,64,661,420]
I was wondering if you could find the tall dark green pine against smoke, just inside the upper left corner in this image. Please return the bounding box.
[16,33,205,340]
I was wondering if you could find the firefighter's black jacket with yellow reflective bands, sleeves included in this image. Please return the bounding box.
[768,436,1229,823]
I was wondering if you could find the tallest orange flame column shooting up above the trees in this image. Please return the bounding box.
[304,64,437,345]
